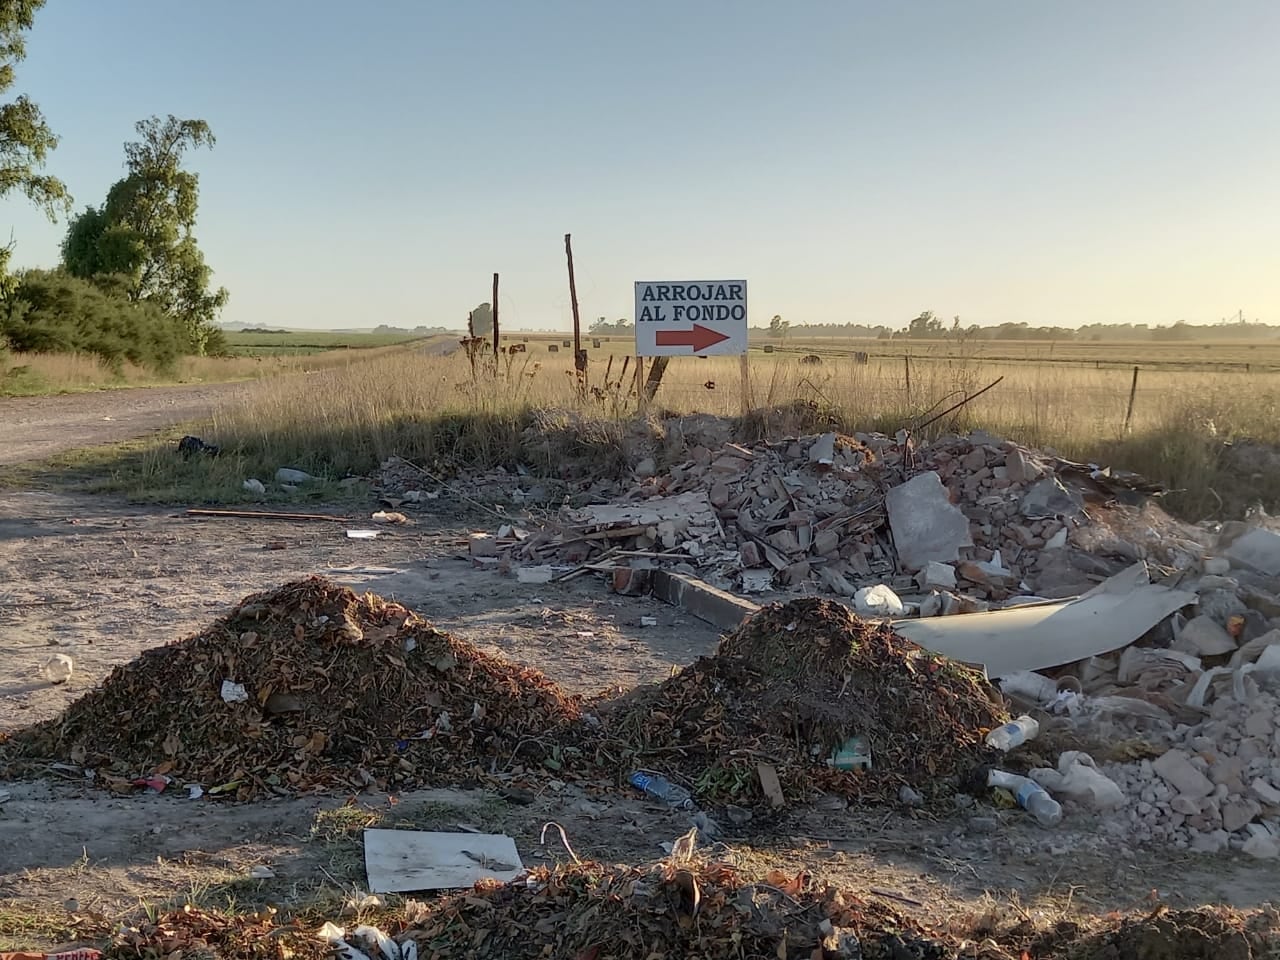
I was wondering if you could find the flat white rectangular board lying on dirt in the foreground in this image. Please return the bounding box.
[365,829,525,893]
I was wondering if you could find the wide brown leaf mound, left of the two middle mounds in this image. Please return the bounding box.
[5,577,581,799]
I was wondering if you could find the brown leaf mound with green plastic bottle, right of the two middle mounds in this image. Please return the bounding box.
[602,598,1007,805]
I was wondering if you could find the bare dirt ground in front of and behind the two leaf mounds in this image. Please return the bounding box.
[0,492,1276,947]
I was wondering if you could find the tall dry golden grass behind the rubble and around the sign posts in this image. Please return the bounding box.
[117,351,1280,517]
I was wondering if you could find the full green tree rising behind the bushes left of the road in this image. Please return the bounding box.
[60,113,228,353]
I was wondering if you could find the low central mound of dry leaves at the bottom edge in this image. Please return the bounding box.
[397,863,951,960]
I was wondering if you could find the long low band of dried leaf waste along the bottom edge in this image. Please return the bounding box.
[104,880,1280,960]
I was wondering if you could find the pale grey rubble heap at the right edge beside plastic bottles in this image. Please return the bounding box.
[972,524,1280,859]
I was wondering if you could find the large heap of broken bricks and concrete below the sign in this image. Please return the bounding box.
[453,425,1198,614]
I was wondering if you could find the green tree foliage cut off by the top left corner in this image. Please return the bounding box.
[0,0,72,220]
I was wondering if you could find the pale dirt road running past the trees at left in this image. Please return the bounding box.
[0,383,246,466]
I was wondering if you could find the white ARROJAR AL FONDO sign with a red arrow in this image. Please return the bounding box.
[636,280,746,357]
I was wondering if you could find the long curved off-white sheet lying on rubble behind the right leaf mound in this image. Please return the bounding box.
[893,563,1196,677]
